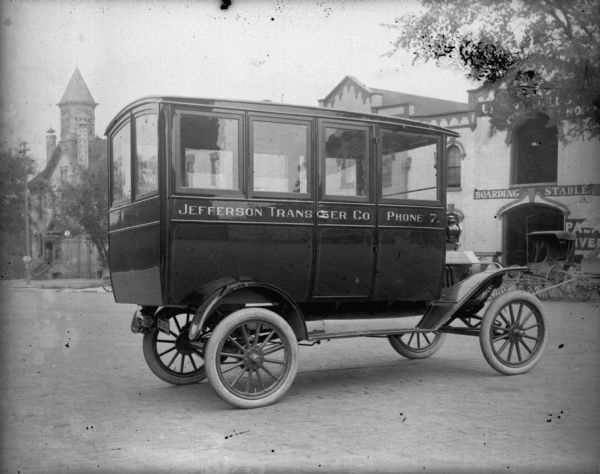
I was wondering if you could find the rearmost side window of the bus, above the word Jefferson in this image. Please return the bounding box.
[176,114,240,191]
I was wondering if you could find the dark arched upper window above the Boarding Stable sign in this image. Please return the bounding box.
[512,116,558,184]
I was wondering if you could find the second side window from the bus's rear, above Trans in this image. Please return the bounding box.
[252,120,308,195]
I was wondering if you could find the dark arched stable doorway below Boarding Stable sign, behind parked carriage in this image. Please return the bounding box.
[503,204,564,265]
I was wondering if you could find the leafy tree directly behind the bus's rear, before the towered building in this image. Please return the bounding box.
[57,155,108,267]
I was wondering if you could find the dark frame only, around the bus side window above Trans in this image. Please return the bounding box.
[246,114,314,200]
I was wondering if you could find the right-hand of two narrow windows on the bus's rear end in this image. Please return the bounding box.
[134,114,158,199]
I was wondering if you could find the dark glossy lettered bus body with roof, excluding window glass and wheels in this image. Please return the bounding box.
[107,98,456,305]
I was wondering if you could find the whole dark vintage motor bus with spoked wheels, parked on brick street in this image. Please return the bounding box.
[106,97,547,408]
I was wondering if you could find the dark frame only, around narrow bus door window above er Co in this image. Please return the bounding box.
[316,119,376,204]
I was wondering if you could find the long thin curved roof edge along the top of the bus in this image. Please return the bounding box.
[105,96,459,137]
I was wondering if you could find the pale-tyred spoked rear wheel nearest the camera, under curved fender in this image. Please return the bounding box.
[204,308,298,408]
